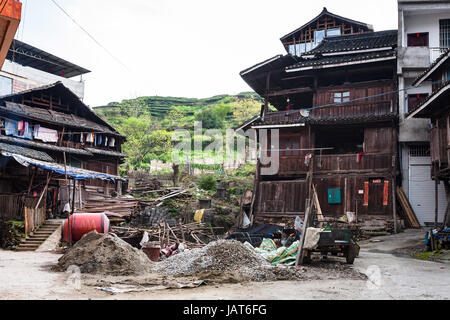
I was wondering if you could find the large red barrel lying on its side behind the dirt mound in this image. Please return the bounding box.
[63,213,109,242]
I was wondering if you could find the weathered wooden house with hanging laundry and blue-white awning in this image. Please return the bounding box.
[0,82,125,231]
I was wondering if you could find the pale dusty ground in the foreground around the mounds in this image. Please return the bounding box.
[0,230,450,300]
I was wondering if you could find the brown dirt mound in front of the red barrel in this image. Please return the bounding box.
[57,231,153,275]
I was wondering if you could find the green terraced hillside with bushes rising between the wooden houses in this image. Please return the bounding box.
[94,92,262,169]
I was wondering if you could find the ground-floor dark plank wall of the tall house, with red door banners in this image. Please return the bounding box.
[256,174,393,218]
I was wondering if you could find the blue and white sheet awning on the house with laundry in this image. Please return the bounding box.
[3,152,124,182]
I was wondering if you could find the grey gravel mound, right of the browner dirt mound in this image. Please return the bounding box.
[154,240,302,282]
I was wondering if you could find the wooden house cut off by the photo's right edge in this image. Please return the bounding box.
[407,49,450,226]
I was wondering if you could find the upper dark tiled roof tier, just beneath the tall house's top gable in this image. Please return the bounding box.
[304,30,398,55]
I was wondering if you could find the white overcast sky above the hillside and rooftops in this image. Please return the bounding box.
[16,0,397,106]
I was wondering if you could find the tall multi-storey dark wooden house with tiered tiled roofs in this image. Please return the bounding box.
[241,10,398,222]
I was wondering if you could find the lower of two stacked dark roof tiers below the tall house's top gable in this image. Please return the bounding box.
[286,50,396,70]
